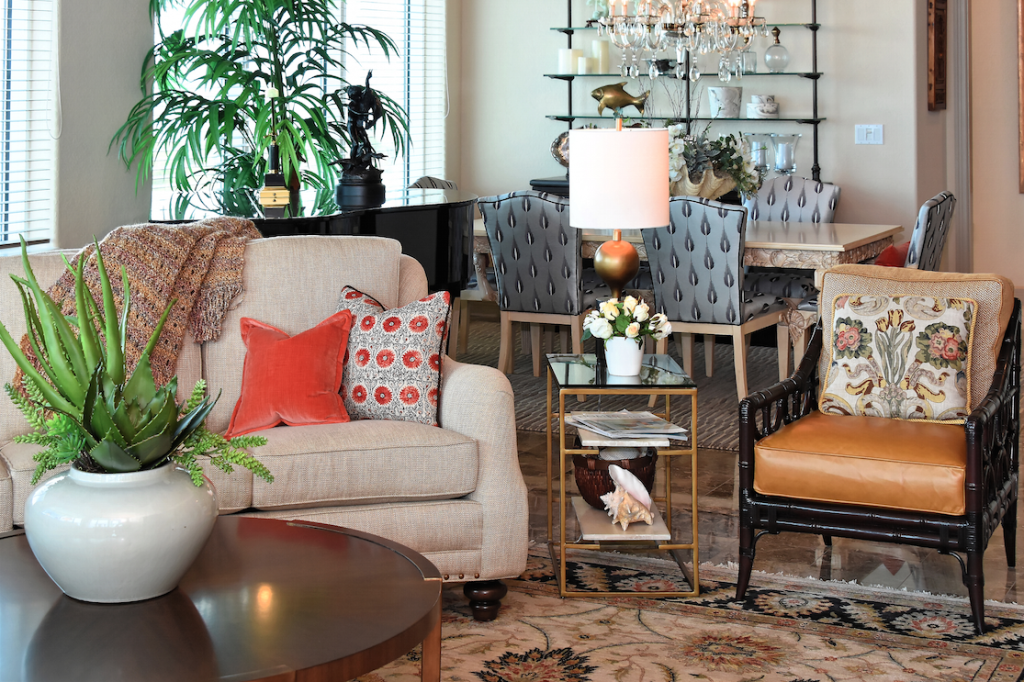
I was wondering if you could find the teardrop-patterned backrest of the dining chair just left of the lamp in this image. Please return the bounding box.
[476,189,584,315]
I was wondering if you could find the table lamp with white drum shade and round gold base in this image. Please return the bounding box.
[569,119,669,298]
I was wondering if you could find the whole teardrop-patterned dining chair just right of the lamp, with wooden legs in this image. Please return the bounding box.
[643,197,788,399]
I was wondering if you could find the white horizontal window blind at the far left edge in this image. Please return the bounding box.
[0,0,56,248]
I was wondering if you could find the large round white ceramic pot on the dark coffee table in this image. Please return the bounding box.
[25,465,217,603]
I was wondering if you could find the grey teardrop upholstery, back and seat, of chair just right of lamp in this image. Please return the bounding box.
[643,197,785,325]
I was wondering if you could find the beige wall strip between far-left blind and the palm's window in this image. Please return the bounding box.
[55,0,153,248]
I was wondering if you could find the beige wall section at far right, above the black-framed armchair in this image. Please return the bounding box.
[971,2,1024,280]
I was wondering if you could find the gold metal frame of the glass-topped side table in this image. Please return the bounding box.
[547,356,700,597]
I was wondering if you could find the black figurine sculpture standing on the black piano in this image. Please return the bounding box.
[335,71,387,209]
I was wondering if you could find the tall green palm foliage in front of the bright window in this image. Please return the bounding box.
[111,0,409,194]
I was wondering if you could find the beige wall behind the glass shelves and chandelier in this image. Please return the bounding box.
[457,0,946,242]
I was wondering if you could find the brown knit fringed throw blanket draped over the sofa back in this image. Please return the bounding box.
[14,217,260,390]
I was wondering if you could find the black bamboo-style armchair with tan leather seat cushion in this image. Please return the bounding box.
[736,265,1021,633]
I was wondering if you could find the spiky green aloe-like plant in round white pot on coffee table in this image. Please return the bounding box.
[0,239,273,602]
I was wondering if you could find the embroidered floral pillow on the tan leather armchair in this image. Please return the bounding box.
[818,295,976,423]
